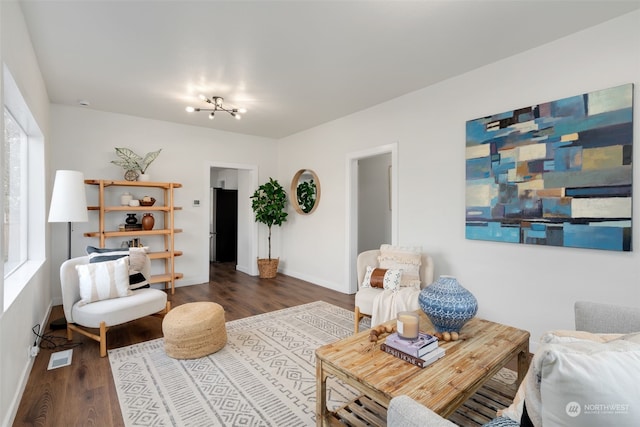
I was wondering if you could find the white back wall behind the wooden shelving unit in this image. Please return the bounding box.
[51,105,277,304]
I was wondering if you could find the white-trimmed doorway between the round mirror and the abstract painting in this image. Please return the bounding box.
[345,142,398,293]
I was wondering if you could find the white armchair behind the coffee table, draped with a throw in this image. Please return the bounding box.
[354,245,433,333]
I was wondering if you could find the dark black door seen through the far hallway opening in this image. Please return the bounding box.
[214,188,238,262]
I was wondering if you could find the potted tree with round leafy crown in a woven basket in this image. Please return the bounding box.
[251,178,288,279]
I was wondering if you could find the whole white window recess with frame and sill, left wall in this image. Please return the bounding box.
[0,65,46,312]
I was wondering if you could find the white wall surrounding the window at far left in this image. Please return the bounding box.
[0,1,51,426]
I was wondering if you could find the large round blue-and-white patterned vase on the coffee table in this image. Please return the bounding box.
[418,276,478,332]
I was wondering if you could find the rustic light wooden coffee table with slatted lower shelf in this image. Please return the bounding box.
[316,310,529,426]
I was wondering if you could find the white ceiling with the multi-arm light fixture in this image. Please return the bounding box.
[21,0,640,138]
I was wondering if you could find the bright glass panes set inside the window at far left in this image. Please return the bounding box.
[2,108,28,278]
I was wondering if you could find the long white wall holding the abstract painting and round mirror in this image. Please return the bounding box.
[278,12,640,348]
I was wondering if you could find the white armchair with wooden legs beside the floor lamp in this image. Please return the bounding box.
[60,256,171,357]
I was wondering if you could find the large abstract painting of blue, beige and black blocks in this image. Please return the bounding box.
[465,84,633,251]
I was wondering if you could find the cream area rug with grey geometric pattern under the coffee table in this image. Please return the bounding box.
[109,301,369,427]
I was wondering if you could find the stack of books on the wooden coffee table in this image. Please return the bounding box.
[380,332,444,368]
